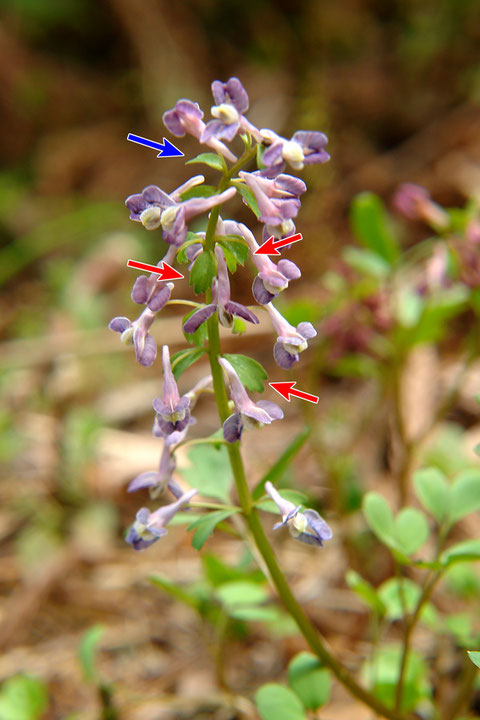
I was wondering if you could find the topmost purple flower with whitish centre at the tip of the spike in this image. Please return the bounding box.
[200,78,262,143]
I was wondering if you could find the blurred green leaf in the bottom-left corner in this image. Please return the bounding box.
[0,675,48,720]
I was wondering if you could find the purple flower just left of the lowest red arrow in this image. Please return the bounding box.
[218,358,283,443]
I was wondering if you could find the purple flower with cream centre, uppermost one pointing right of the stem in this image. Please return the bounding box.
[260,129,330,177]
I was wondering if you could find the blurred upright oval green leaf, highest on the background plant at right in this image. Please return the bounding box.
[350,192,400,265]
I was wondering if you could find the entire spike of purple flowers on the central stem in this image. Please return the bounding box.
[109,77,331,550]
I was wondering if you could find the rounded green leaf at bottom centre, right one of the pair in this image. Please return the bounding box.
[288,652,331,710]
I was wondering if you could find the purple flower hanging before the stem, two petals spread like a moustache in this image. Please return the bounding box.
[183,245,258,334]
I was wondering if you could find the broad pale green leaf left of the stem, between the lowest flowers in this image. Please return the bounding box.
[179,445,233,502]
